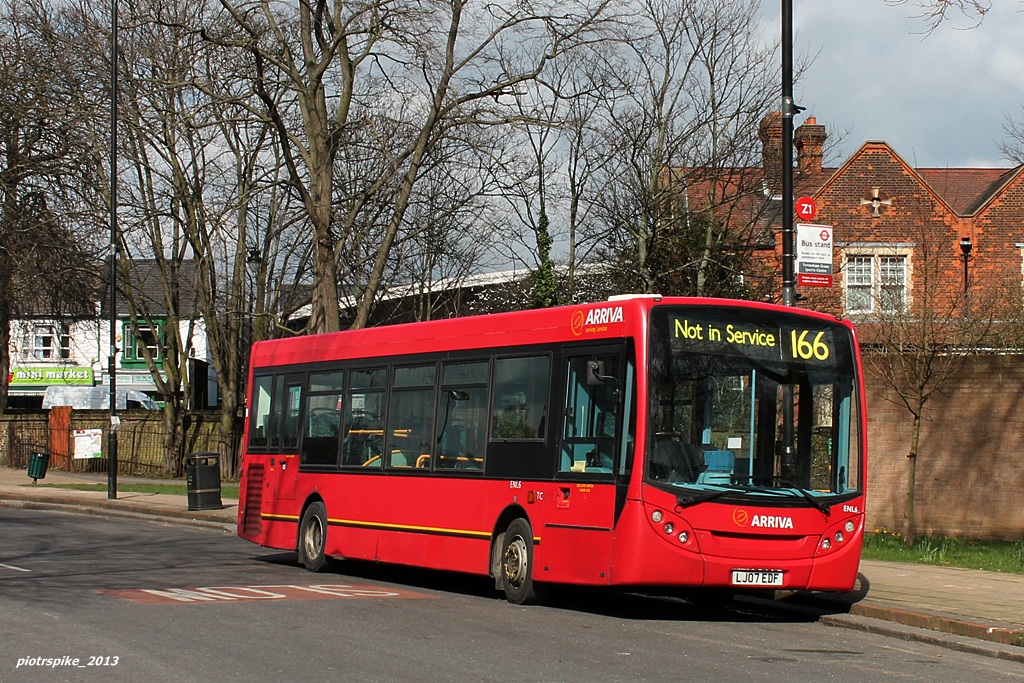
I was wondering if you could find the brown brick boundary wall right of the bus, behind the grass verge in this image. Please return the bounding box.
[867,355,1024,541]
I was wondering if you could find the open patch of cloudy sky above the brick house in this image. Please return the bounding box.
[763,0,1024,168]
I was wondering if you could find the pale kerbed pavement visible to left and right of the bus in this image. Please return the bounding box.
[0,467,1024,664]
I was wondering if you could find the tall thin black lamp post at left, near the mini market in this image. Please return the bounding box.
[106,0,120,500]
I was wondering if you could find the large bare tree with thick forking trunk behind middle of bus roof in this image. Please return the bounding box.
[204,0,603,331]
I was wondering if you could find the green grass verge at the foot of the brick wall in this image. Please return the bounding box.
[863,531,1024,574]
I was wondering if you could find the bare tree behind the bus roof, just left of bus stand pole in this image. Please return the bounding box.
[595,0,777,294]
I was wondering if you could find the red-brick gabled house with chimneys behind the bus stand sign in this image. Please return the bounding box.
[761,115,1024,324]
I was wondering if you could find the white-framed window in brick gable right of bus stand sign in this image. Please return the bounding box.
[845,253,907,313]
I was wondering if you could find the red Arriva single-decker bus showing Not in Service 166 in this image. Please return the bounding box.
[238,296,866,603]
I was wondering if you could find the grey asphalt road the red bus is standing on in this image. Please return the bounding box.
[0,509,1024,683]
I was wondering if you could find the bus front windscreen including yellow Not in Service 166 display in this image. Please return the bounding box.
[647,306,861,505]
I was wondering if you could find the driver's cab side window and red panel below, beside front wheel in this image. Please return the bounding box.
[545,346,626,584]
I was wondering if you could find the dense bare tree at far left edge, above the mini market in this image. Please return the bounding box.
[0,0,107,412]
